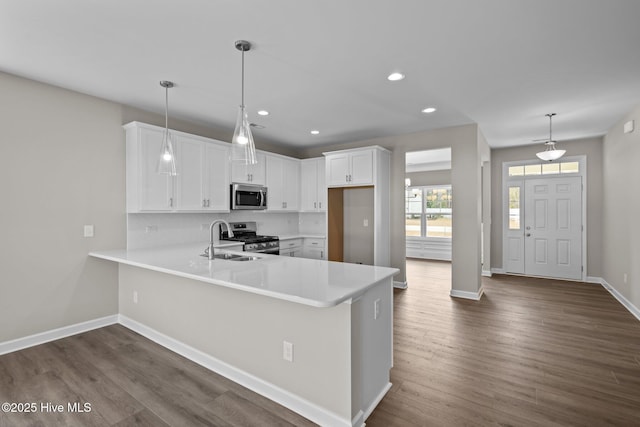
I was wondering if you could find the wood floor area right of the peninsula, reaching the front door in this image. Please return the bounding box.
[367,260,640,427]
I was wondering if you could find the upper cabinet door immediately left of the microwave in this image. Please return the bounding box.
[204,143,230,211]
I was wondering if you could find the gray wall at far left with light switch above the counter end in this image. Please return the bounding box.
[0,73,126,342]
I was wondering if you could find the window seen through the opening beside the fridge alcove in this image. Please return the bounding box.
[405,185,452,239]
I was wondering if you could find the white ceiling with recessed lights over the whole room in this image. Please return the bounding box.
[0,0,640,147]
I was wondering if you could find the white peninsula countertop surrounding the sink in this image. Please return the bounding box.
[89,243,399,307]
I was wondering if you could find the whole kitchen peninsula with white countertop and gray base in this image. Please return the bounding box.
[90,244,398,426]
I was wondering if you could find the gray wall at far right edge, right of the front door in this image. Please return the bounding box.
[601,106,640,309]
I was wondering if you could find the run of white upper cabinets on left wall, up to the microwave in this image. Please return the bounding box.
[124,122,229,212]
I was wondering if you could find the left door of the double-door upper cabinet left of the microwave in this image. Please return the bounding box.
[176,136,206,211]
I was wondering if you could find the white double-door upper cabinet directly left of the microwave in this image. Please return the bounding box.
[176,135,229,212]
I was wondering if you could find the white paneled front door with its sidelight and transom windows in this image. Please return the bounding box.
[503,157,585,280]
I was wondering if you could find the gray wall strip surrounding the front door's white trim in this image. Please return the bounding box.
[491,138,603,277]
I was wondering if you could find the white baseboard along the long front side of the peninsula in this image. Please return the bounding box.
[118,315,356,427]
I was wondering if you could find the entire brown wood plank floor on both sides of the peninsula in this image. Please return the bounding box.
[0,260,640,427]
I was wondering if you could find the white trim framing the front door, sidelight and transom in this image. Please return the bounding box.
[502,155,588,282]
